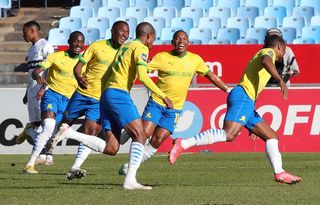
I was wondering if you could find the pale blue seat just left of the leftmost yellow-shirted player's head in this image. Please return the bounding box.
[48,28,71,46]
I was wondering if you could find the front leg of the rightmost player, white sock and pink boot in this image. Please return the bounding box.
[252,121,301,184]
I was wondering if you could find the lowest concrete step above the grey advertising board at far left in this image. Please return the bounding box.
[0,72,28,85]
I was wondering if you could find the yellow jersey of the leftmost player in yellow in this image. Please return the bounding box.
[38,51,80,98]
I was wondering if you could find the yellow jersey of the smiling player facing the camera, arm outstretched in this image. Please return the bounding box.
[148,51,210,110]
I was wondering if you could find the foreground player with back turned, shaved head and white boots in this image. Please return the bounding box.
[53,22,173,190]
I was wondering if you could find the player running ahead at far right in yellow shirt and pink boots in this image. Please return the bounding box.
[169,36,301,184]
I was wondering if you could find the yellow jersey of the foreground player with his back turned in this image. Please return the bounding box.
[104,39,166,98]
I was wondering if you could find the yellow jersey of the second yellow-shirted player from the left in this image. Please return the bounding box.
[77,40,119,100]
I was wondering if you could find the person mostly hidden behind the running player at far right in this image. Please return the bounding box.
[265,28,300,86]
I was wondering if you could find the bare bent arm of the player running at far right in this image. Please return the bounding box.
[261,55,288,99]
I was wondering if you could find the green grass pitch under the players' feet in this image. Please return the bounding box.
[0,153,320,205]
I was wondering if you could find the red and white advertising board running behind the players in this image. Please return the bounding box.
[0,87,320,154]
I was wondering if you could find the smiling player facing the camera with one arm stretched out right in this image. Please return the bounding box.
[119,30,231,175]
